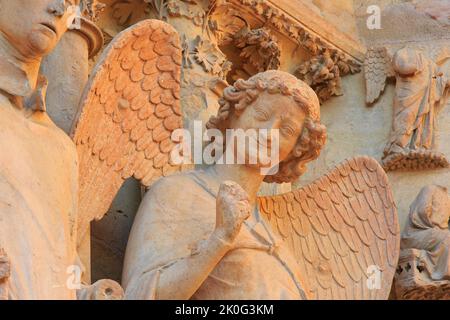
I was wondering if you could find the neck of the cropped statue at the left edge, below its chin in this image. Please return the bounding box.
[0,33,41,101]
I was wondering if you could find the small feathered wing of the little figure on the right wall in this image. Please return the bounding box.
[364,47,395,104]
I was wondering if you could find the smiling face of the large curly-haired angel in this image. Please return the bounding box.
[231,92,306,167]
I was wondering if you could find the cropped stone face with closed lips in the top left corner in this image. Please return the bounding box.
[0,0,79,59]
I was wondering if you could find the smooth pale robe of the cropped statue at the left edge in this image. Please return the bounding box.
[0,89,78,300]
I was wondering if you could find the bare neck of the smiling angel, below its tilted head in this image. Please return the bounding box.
[209,164,264,205]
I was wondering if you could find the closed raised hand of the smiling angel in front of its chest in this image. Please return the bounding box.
[214,181,251,243]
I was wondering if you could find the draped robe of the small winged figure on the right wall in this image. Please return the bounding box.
[385,58,448,155]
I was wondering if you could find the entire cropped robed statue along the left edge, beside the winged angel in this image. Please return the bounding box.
[0,0,78,299]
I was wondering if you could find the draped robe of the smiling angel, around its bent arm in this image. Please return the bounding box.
[122,173,310,300]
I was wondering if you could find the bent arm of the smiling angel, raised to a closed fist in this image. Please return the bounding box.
[125,184,250,300]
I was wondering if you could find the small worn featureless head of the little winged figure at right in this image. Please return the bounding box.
[392,48,424,77]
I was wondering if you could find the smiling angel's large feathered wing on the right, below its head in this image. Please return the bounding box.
[259,157,400,300]
